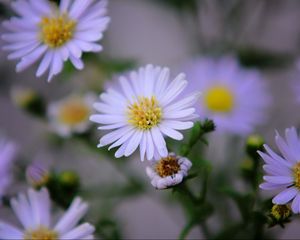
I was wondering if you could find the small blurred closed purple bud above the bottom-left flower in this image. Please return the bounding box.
[26,162,50,188]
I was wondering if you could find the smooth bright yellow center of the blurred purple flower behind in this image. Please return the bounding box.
[204,86,234,113]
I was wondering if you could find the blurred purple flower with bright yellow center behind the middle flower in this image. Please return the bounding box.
[186,57,270,135]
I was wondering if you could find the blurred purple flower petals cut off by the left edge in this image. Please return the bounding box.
[0,139,17,200]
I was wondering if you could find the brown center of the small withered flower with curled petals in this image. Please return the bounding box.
[155,156,180,177]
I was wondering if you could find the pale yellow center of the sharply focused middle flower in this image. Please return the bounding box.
[128,97,162,131]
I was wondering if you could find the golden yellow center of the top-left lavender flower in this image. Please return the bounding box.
[39,14,76,48]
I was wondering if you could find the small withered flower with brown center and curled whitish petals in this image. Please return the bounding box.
[146,153,192,189]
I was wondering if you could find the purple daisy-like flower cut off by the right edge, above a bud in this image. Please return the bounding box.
[258,127,300,213]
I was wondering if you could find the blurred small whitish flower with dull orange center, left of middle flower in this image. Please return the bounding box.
[48,94,96,137]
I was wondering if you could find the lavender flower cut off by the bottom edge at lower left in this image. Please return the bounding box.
[0,188,95,240]
